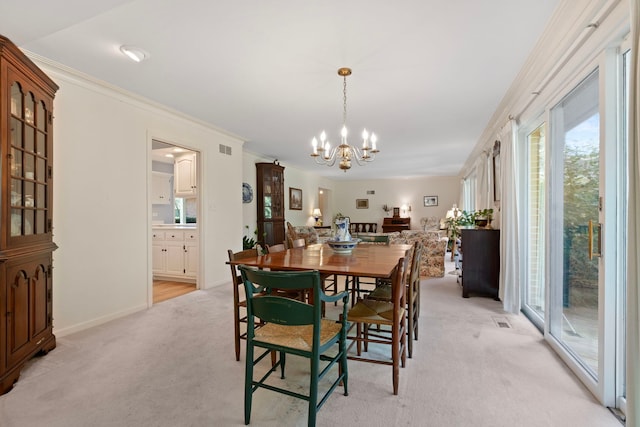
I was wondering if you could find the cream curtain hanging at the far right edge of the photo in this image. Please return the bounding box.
[626,0,640,426]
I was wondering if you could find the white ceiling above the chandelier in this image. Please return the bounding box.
[0,0,560,179]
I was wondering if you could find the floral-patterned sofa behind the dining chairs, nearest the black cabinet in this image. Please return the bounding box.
[389,230,449,277]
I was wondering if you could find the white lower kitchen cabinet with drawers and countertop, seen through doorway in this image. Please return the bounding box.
[152,228,198,280]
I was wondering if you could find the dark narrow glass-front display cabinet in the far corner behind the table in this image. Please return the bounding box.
[256,162,285,245]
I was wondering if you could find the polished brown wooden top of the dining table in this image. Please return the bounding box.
[227,243,411,278]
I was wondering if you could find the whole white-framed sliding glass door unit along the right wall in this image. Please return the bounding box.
[518,34,630,412]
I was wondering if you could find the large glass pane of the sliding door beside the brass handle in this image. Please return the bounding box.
[549,70,602,381]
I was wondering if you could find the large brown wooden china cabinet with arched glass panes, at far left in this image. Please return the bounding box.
[0,36,58,394]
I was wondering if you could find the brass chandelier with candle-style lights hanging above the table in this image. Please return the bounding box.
[311,68,380,172]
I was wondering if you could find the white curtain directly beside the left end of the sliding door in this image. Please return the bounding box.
[498,118,520,314]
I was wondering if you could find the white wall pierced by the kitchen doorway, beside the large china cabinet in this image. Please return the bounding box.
[39,62,243,336]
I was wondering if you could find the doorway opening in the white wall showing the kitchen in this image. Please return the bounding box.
[149,139,201,304]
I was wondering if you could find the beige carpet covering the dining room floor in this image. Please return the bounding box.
[0,263,620,427]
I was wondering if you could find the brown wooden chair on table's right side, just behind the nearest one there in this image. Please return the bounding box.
[367,242,423,358]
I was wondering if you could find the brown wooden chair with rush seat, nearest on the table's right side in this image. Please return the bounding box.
[347,256,409,395]
